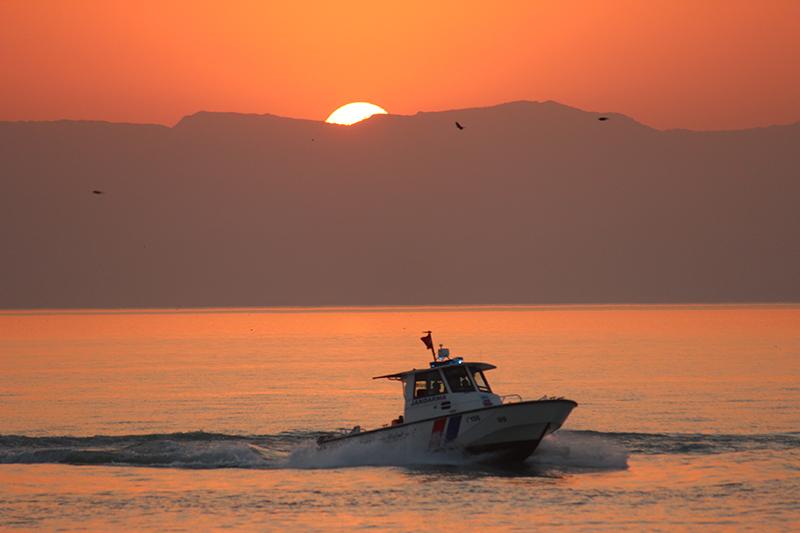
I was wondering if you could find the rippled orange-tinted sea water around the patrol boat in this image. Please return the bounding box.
[0,305,800,533]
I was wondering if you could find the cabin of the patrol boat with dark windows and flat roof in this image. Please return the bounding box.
[373,348,502,423]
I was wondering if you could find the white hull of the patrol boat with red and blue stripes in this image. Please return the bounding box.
[319,399,578,462]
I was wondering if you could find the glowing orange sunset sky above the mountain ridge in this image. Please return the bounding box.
[0,0,800,130]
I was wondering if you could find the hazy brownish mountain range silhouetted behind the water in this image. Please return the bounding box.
[0,102,800,309]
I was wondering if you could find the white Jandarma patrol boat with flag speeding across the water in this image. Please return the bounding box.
[317,332,578,463]
